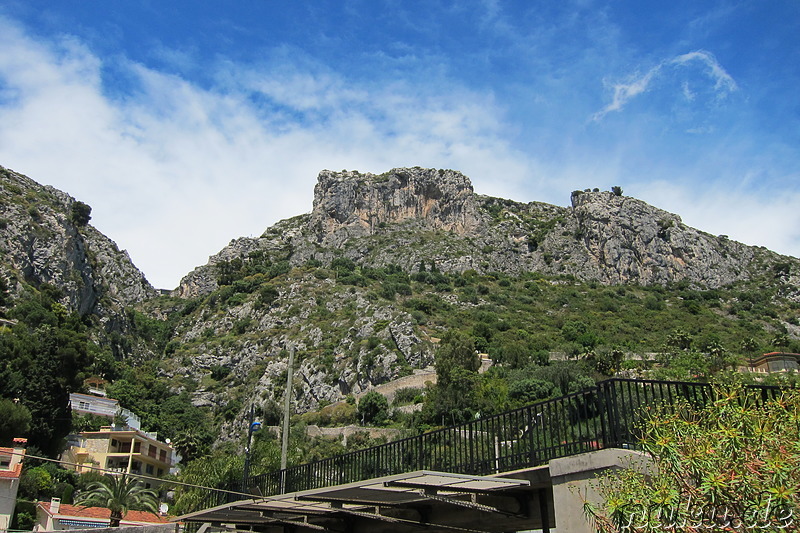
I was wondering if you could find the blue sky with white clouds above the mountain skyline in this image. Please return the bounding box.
[0,0,800,288]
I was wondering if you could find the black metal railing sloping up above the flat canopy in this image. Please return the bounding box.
[209,378,779,505]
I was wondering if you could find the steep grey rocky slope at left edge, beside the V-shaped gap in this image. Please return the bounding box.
[0,167,157,320]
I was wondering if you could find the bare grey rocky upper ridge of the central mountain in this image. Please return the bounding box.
[177,167,777,297]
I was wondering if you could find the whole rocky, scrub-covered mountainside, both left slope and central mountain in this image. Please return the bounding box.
[0,167,800,456]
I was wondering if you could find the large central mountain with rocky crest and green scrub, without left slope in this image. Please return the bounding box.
[148,168,800,436]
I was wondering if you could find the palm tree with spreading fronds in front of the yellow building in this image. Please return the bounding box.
[75,474,159,527]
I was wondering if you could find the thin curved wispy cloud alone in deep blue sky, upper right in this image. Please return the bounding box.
[591,50,738,122]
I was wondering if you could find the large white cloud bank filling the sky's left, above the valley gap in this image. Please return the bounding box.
[0,20,527,288]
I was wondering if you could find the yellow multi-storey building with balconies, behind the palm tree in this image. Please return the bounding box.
[62,426,174,488]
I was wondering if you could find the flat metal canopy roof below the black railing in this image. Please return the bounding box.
[175,470,530,532]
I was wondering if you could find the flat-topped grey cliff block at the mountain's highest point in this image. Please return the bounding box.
[311,167,481,241]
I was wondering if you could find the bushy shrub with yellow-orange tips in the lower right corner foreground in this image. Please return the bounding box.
[585,385,800,533]
